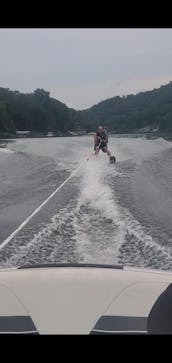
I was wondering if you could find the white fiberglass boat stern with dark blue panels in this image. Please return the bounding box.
[0,265,172,334]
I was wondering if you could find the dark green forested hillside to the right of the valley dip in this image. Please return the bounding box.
[80,82,172,132]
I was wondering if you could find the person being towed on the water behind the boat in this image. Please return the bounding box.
[94,126,115,162]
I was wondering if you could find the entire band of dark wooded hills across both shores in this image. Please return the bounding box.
[0,81,172,135]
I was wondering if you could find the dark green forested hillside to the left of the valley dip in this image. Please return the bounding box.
[0,87,79,133]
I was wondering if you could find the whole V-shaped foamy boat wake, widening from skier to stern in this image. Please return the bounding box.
[1,150,172,269]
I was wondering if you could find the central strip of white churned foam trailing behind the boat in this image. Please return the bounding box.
[72,154,126,263]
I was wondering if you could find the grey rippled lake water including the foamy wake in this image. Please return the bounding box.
[0,136,172,270]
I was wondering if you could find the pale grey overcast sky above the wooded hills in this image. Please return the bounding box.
[0,28,172,110]
